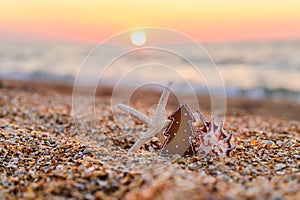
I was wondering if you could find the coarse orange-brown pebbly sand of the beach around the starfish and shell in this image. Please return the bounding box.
[0,80,300,199]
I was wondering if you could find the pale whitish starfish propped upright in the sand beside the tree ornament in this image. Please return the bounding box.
[117,81,173,152]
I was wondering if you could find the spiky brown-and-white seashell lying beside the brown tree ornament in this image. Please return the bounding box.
[195,111,236,158]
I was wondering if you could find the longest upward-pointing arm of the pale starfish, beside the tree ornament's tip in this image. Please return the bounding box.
[155,81,173,122]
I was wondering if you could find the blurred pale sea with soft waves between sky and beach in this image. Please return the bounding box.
[0,41,300,103]
